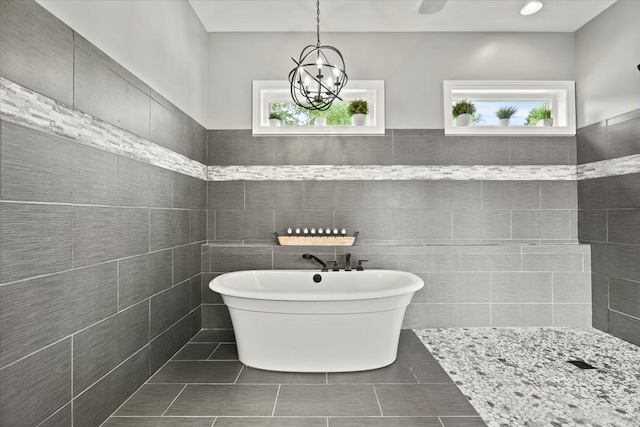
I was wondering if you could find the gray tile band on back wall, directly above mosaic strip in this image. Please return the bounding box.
[207,129,576,166]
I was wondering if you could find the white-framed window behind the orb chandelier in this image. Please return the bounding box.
[252,80,385,135]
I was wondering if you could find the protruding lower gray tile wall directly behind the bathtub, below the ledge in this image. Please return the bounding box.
[202,244,591,329]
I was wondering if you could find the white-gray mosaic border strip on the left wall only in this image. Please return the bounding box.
[0,77,207,180]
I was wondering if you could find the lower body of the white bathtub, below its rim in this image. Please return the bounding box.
[229,306,406,372]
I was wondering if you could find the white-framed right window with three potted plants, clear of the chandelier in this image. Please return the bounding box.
[443,80,576,135]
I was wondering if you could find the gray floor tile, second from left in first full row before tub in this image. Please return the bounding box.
[167,382,278,416]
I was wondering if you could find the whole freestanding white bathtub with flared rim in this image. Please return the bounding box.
[209,270,424,372]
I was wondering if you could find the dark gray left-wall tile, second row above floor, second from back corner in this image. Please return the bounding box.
[149,281,191,339]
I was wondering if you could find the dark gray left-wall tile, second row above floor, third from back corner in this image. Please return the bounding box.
[73,301,149,396]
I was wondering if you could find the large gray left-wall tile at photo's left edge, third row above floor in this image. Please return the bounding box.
[0,262,118,366]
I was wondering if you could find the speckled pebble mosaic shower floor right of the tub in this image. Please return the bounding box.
[416,328,640,427]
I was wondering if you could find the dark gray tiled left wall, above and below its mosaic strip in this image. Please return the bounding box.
[0,0,206,426]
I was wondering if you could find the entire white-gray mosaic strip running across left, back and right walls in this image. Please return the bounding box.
[0,77,640,181]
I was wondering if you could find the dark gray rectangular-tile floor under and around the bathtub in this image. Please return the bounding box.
[103,330,485,427]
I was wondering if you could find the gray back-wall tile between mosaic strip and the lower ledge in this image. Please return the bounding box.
[208,181,577,244]
